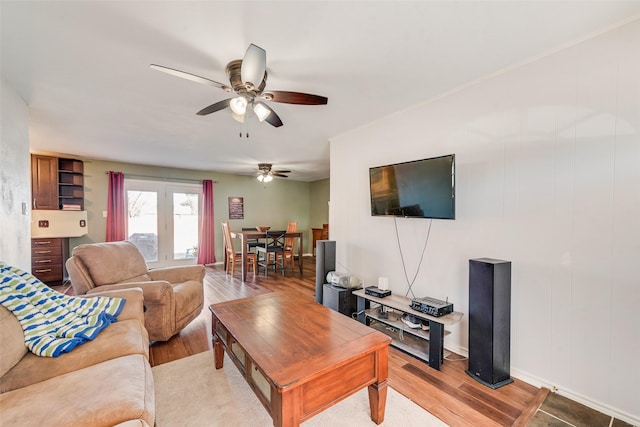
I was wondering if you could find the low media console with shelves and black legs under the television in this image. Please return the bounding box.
[353,289,463,370]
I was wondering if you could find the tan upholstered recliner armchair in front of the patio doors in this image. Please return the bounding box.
[66,241,205,341]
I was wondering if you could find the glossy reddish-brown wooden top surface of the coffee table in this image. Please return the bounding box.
[209,292,391,389]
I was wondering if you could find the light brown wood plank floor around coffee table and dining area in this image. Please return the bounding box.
[151,257,549,426]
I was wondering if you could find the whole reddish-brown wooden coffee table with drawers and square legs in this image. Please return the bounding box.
[209,292,391,427]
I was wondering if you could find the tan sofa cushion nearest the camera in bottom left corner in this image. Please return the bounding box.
[0,354,155,427]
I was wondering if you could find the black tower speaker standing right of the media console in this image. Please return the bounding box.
[467,258,513,389]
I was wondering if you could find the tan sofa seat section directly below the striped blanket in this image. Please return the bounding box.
[0,320,149,393]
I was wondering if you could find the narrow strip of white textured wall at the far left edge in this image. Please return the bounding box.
[0,80,31,271]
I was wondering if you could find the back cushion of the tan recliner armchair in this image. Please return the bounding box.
[73,241,148,286]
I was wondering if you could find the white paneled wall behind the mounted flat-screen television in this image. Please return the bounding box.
[330,21,640,425]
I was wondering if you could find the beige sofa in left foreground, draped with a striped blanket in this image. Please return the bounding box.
[0,288,155,427]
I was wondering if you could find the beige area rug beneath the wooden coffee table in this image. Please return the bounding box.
[152,351,446,427]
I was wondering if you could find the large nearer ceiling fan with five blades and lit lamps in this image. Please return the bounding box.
[150,44,327,127]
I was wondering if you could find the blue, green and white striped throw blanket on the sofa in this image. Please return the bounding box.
[0,262,125,357]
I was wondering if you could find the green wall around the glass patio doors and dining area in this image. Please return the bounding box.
[69,158,318,261]
